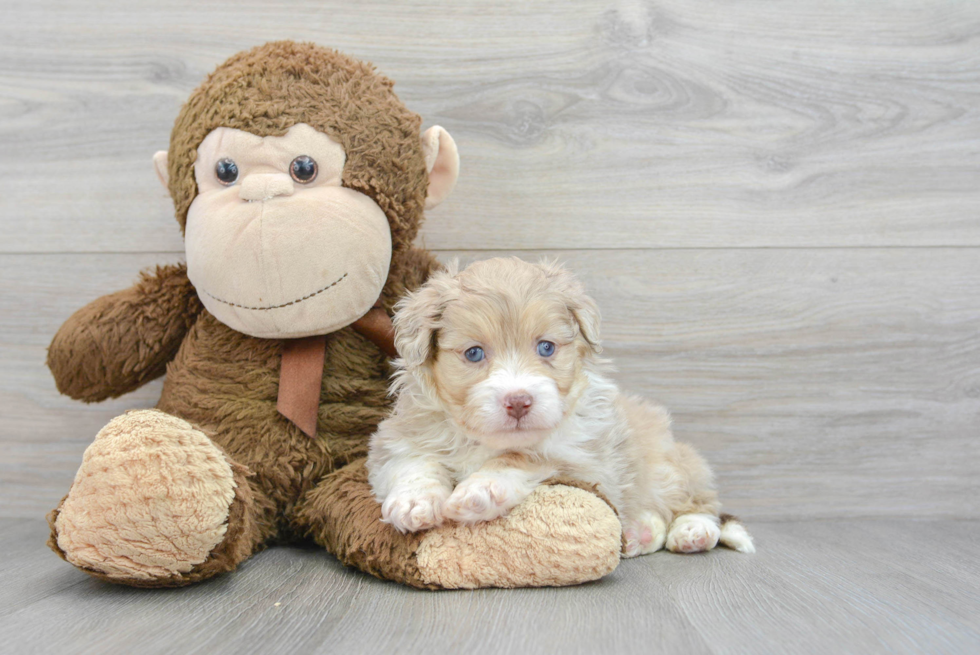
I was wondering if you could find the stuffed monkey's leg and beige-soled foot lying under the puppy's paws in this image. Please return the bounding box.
[295,459,622,589]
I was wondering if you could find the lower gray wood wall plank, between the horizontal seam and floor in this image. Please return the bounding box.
[0,248,980,519]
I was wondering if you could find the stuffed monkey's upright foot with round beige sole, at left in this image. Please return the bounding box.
[48,410,251,587]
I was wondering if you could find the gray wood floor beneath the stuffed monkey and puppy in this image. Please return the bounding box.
[0,520,980,655]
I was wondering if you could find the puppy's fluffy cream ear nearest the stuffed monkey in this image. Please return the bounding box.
[392,262,456,370]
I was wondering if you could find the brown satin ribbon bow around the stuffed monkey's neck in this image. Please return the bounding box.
[276,298,398,437]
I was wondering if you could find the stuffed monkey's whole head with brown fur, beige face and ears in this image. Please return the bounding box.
[154,41,459,338]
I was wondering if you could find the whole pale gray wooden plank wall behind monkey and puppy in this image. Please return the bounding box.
[0,0,980,520]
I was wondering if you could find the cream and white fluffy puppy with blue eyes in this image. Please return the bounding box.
[367,259,755,557]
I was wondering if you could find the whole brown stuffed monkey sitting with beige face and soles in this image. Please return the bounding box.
[48,41,620,588]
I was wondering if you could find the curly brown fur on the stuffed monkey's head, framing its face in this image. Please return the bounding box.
[167,41,427,252]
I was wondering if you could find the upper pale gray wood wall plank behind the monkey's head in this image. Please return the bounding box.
[0,0,980,252]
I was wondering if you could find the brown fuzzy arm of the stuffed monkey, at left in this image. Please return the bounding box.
[47,264,202,402]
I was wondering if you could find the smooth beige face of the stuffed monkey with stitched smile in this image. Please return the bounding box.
[184,123,392,339]
